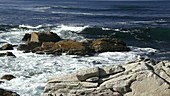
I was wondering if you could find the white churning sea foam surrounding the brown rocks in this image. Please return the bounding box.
[0,25,157,96]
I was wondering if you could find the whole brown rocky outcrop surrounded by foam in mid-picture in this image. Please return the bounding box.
[17,32,130,56]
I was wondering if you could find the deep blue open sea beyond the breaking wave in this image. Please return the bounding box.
[0,0,170,28]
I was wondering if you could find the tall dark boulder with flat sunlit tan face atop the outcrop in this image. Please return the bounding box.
[28,32,61,42]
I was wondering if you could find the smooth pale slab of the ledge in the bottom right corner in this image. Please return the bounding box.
[125,75,170,96]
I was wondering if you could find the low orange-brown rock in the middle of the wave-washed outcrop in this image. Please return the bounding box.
[40,40,90,55]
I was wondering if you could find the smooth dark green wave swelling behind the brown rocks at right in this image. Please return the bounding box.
[80,27,170,41]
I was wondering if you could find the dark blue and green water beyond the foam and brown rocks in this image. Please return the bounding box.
[0,0,170,57]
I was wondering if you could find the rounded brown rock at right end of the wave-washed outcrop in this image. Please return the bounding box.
[91,38,130,52]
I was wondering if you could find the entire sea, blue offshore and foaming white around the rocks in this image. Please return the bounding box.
[0,0,170,96]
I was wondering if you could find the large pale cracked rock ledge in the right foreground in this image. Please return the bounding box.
[43,60,170,96]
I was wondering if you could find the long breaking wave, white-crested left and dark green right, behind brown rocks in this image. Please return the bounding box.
[0,21,170,42]
